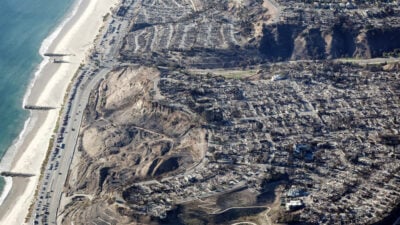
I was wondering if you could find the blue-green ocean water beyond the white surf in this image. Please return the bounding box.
[0,0,74,191]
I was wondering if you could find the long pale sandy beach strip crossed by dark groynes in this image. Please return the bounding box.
[0,0,118,225]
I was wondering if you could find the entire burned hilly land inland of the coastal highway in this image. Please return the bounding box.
[54,0,400,225]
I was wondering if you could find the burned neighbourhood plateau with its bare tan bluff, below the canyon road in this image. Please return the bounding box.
[60,62,400,225]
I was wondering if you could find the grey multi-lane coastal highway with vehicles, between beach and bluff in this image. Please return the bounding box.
[29,3,133,225]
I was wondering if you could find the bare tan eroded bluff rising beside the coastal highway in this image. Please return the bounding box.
[64,68,206,224]
